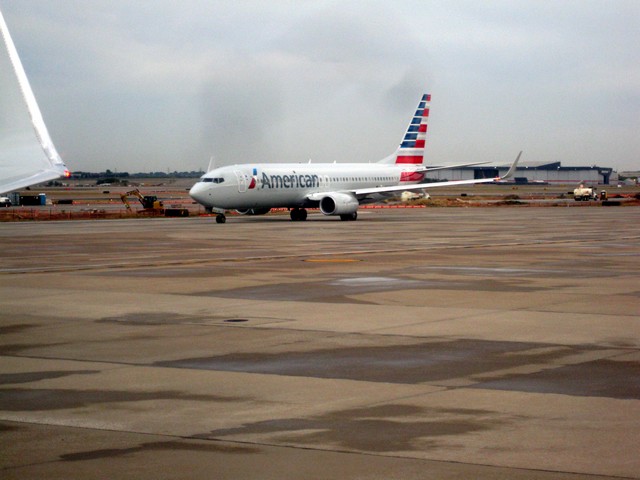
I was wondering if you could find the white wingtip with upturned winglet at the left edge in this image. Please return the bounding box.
[0,7,71,193]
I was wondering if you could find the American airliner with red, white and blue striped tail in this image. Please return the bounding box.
[189,94,522,223]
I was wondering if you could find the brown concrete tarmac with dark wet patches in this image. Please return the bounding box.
[0,207,640,480]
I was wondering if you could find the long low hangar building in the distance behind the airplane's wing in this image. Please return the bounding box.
[427,162,613,185]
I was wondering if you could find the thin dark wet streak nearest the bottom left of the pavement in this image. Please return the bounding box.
[59,440,261,462]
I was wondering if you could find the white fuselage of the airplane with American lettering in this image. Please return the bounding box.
[189,163,422,209]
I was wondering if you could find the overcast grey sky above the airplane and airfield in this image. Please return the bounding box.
[0,0,640,172]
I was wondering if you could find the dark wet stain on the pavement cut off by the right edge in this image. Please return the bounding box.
[472,359,640,399]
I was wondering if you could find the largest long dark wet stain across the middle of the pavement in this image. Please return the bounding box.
[156,340,576,384]
